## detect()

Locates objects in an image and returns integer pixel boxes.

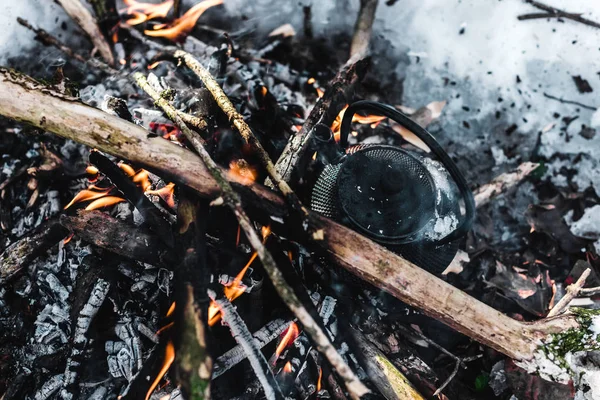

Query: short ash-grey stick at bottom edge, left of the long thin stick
[208,290,284,399]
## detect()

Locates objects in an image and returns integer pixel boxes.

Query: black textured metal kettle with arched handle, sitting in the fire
[311,100,475,274]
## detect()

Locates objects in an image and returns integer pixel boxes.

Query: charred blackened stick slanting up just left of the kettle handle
[267,58,368,186]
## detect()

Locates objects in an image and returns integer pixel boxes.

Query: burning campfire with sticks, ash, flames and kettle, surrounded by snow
[0,0,600,400]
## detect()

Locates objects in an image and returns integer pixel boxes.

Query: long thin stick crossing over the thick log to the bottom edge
[135,73,369,399]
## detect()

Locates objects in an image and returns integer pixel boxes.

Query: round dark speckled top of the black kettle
[338,145,435,241]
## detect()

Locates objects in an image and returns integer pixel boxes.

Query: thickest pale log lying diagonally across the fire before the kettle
[0,69,579,360]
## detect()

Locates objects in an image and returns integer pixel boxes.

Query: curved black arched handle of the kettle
[340,100,475,244]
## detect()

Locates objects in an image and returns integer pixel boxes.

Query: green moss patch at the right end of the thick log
[542,308,600,371]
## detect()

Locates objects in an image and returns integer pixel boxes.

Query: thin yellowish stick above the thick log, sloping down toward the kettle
[175,50,308,216]
